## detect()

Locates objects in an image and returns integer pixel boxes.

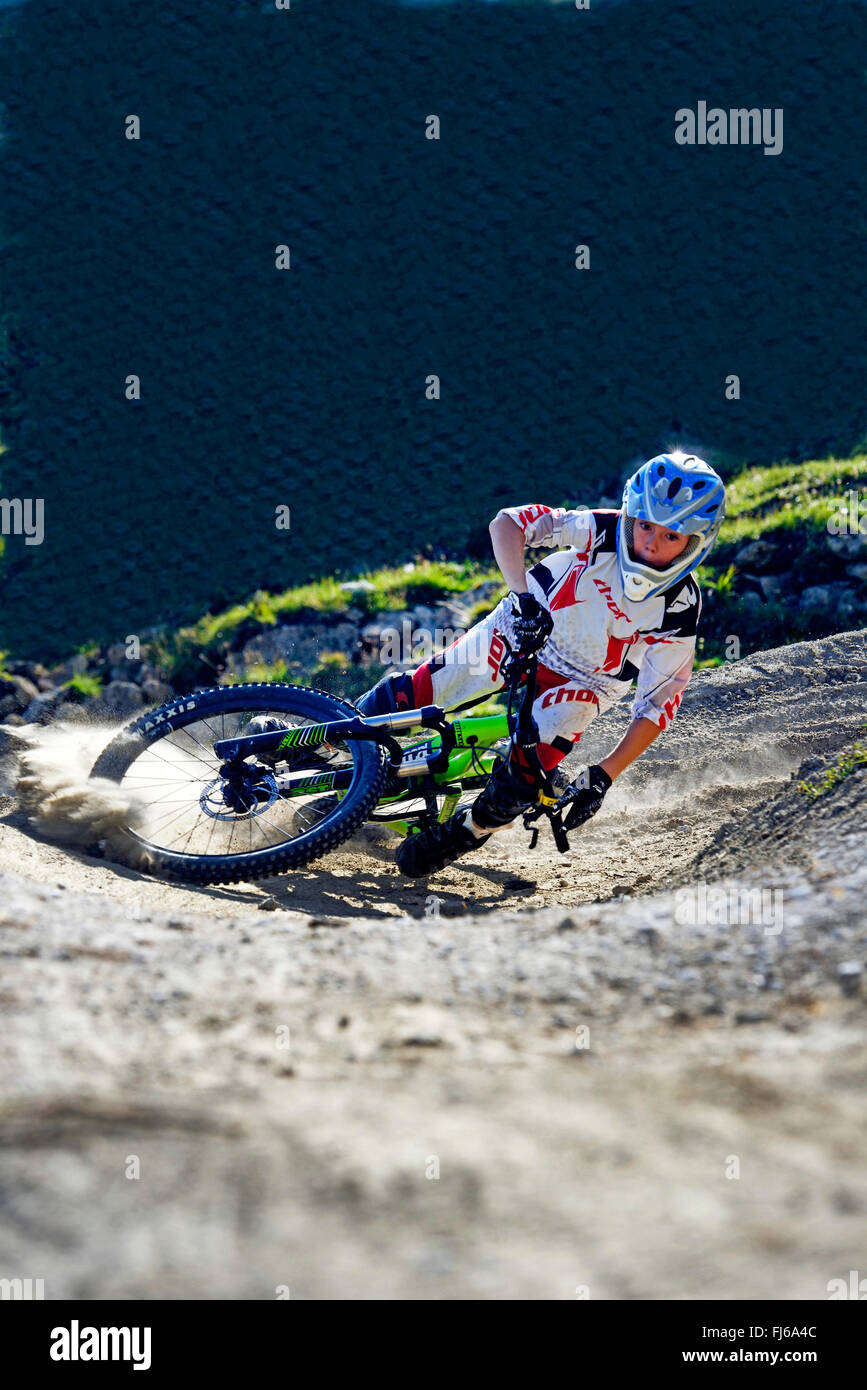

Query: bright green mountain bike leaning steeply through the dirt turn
[90,649,571,884]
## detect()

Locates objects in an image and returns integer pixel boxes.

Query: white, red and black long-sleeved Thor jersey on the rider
[499,503,702,728]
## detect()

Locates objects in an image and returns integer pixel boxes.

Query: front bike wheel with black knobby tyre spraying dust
[90,682,388,883]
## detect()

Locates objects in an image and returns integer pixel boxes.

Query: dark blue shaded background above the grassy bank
[0,0,867,657]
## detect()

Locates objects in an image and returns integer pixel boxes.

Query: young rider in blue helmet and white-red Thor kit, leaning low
[358,453,725,877]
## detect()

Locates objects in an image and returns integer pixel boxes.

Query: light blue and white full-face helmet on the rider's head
[617,453,725,599]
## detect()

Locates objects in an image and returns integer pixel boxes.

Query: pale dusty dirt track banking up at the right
[0,632,867,1300]
